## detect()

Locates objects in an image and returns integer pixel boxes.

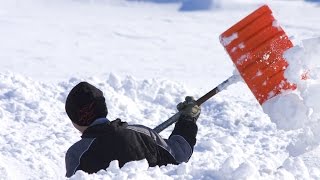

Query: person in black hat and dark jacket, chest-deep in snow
[66,82,200,177]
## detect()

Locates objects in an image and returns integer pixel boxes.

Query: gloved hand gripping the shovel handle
[177,96,201,122]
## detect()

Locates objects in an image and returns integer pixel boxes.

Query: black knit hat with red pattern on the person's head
[65,82,108,126]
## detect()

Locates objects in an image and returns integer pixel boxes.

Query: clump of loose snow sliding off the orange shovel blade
[263,38,320,156]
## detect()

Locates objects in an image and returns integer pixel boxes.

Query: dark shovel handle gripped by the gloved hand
[153,75,240,133]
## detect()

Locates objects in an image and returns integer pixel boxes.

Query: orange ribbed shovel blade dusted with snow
[220,5,296,104]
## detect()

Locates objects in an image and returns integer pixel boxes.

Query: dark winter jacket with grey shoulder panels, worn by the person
[65,116,198,177]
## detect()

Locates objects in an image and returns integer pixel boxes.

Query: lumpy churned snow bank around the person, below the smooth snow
[0,73,319,180]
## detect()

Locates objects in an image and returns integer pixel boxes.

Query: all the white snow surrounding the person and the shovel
[0,0,320,180]
